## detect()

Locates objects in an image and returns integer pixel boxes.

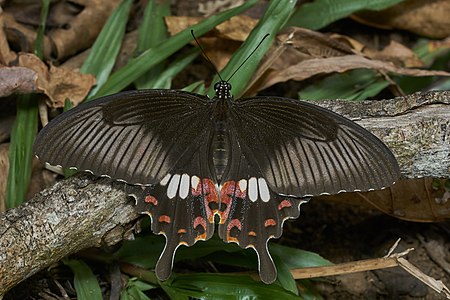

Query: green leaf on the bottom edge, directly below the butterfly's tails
[162,274,298,299]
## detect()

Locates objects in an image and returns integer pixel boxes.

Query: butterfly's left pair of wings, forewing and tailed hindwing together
[34,90,218,279]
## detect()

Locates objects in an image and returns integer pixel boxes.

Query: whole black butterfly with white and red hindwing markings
[34,81,400,283]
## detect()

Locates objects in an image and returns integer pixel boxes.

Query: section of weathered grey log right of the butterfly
[317,91,450,178]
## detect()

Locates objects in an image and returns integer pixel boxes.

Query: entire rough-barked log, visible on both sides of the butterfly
[0,92,450,295]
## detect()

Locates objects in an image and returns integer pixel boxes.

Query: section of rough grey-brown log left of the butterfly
[0,174,139,295]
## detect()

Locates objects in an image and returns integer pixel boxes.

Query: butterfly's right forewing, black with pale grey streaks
[230,97,400,197]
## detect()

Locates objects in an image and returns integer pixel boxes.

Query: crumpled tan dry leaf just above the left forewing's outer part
[19,53,95,107]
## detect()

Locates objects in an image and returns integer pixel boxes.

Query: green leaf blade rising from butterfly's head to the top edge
[208,0,296,98]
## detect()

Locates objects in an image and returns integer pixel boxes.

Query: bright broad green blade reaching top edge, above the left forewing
[80,0,133,100]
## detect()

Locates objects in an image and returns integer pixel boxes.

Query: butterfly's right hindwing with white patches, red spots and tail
[218,136,307,283]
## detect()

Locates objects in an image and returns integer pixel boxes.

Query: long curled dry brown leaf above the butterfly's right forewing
[245,27,436,95]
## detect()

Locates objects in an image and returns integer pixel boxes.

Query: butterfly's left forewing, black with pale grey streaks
[34,90,211,185]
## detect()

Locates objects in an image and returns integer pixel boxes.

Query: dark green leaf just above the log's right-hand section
[299,69,389,100]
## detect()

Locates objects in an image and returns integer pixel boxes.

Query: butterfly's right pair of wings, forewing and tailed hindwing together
[219,97,399,283]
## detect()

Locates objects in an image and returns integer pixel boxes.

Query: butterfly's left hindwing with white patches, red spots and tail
[138,135,219,280]
